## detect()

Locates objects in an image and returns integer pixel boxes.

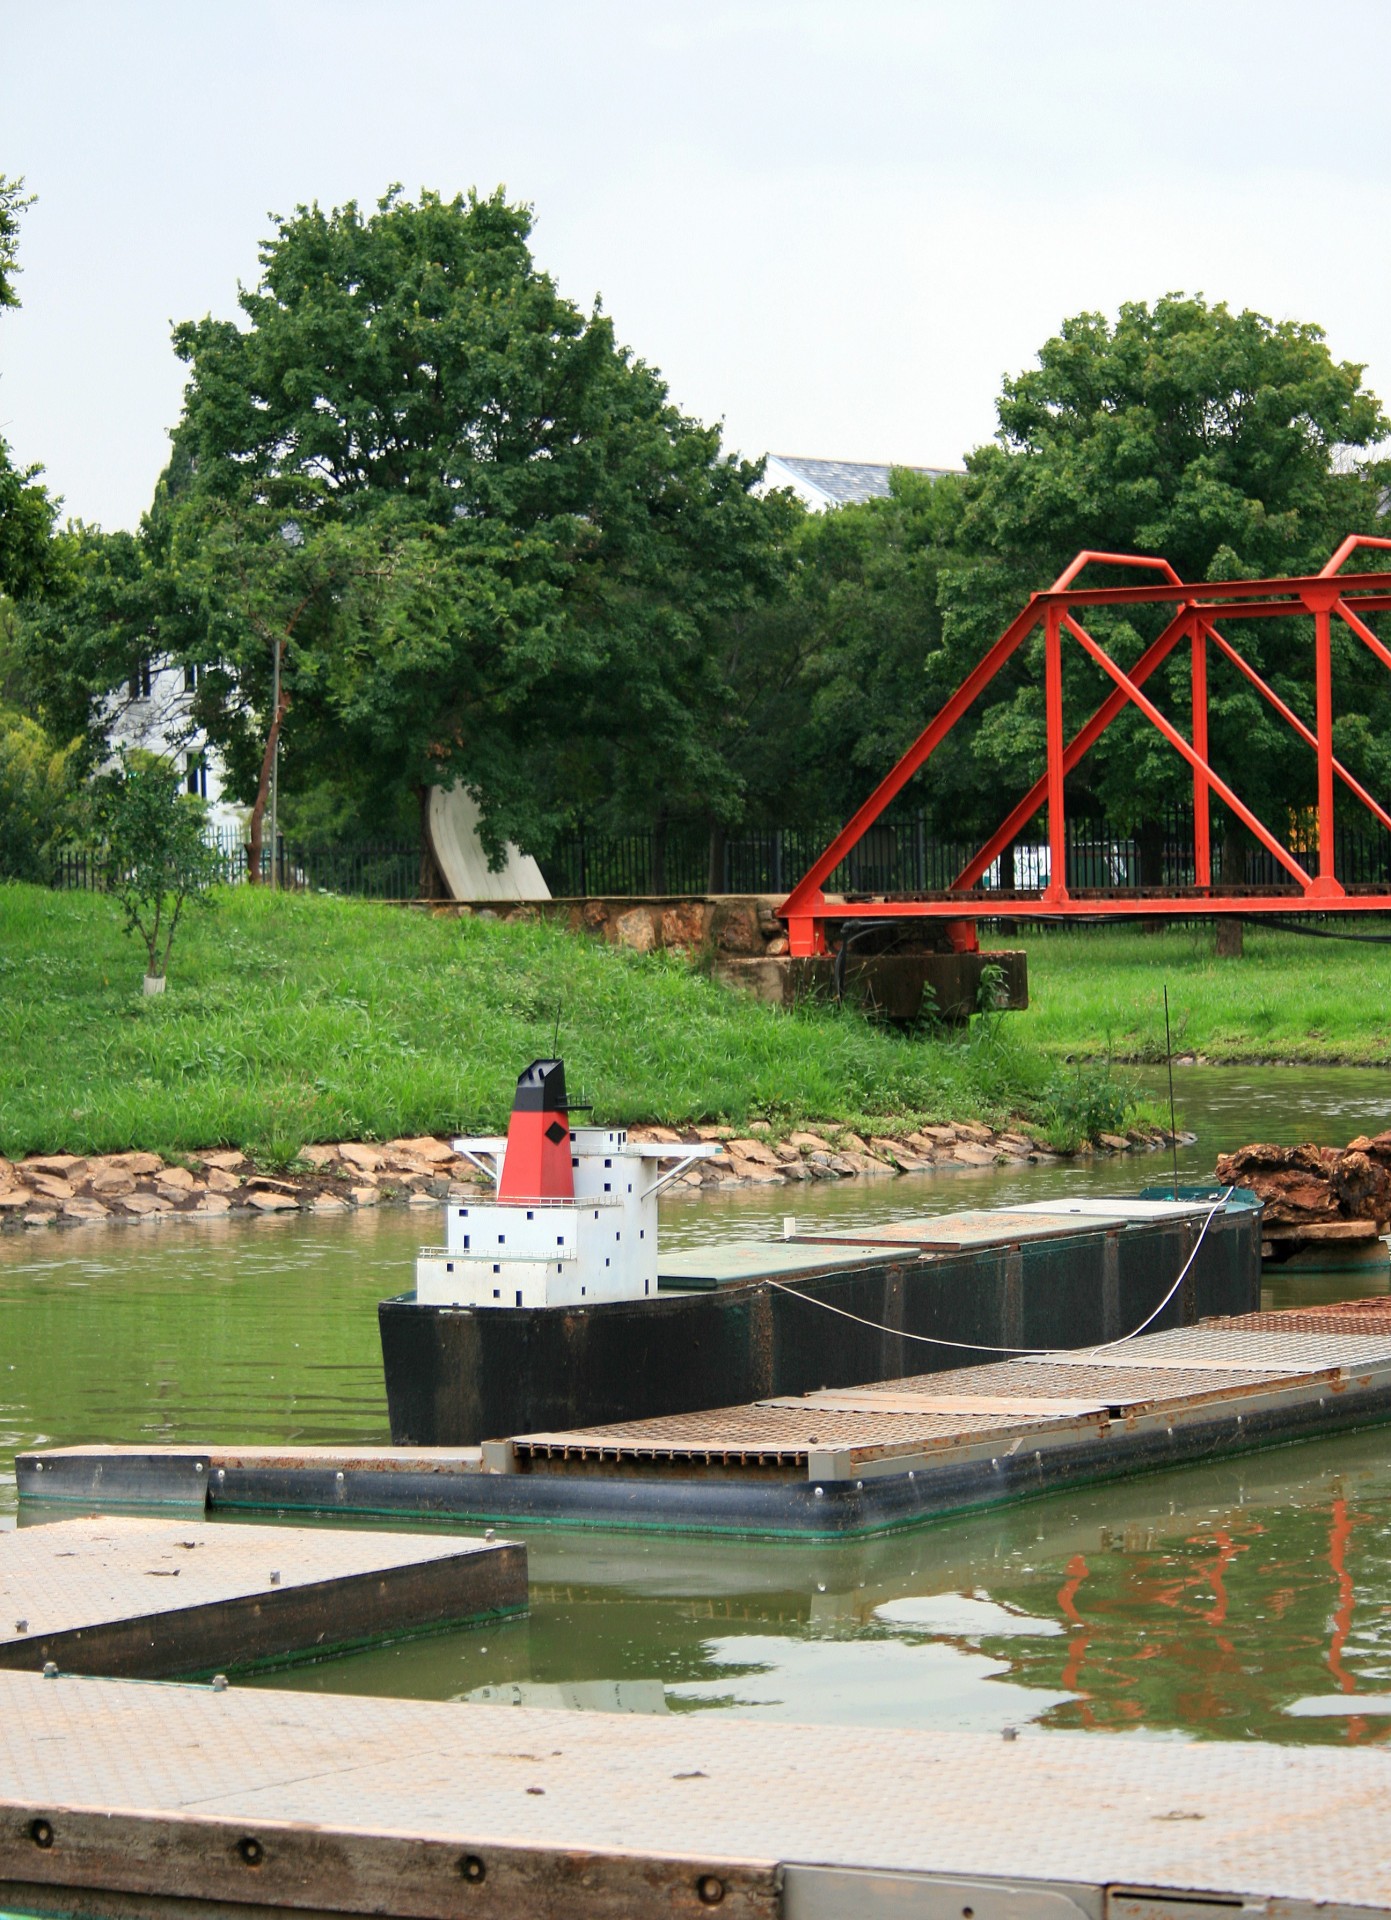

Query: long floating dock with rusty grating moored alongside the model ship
[15,1296,1391,1538]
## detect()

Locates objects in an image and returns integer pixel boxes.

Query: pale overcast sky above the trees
[0,0,1391,526]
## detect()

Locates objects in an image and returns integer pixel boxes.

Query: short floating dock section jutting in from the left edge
[0,1517,526,1678]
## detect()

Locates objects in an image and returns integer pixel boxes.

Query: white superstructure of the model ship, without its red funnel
[415,1127,719,1308]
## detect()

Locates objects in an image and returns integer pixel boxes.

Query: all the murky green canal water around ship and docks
[0,1068,1391,1743]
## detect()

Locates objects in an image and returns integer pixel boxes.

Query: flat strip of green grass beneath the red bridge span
[1022,920,1391,1066]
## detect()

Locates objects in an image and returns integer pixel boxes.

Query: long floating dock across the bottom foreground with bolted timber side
[0,1674,1391,1920]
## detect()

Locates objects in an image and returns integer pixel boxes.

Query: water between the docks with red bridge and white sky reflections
[263,1432,1391,1743]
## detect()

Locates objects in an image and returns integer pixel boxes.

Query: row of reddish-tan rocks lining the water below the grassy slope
[0,1119,1166,1231]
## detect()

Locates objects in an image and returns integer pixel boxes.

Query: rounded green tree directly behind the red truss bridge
[928,296,1391,877]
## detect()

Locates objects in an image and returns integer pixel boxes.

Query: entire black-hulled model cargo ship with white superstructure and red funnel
[378,1060,1260,1448]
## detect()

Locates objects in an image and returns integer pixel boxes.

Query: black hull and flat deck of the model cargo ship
[378,1187,1260,1448]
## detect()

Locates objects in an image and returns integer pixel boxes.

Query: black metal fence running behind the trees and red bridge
[52,810,1391,900]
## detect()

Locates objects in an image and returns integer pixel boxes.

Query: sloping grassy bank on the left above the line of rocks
[0,885,1124,1162]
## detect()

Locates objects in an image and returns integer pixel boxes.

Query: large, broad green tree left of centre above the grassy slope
[167,192,788,871]
